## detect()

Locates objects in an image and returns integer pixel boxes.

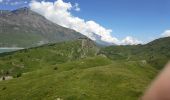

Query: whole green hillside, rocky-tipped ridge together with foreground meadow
[0,38,157,100]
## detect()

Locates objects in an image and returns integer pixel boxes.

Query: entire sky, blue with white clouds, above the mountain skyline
[0,0,170,45]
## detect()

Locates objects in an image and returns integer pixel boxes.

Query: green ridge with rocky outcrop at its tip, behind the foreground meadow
[0,39,98,76]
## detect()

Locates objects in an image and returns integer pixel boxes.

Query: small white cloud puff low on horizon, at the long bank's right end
[121,36,142,45]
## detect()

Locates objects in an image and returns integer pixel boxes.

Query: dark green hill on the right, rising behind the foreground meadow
[100,37,170,69]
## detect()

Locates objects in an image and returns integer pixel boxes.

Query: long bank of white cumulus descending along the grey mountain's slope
[29,0,141,44]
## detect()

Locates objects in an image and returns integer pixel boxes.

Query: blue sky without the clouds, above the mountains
[0,0,170,42]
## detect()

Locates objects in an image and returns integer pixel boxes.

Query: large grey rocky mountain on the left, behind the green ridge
[0,8,85,48]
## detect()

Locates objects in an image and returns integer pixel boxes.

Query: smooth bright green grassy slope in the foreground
[0,56,156,100]
